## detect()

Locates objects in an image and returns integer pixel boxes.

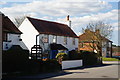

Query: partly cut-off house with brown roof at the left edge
[1,14,28,50]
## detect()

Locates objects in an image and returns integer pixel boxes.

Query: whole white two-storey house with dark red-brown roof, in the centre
[19,17,78,58]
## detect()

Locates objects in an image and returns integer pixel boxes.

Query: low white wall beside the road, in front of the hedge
[62,60,83,69]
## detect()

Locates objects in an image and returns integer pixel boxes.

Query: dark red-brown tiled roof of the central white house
[27,17,78,38]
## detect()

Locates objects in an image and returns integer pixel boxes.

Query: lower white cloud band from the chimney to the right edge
[58,9,118,26]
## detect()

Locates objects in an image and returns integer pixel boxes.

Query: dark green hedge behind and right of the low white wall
[69,50,102,66]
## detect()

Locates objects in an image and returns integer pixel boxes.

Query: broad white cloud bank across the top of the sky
[0,0,111,17]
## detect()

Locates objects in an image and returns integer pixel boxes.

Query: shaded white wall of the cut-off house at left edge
[3,33,28,50]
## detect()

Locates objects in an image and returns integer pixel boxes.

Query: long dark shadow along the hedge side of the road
[2,63,120,80]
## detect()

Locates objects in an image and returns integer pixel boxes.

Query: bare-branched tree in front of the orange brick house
[82,21,113,56]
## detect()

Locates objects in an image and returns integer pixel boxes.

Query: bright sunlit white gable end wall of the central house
[19,18,39,51]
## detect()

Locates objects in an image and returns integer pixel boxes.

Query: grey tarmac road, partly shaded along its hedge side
[2,61,120,80]
